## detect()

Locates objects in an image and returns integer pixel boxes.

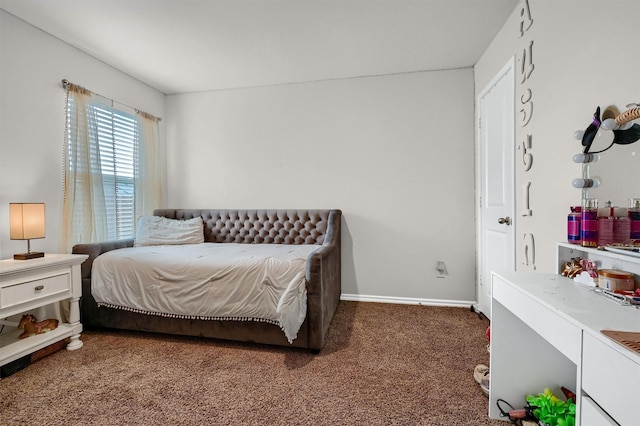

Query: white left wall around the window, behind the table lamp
[0,10,164,259]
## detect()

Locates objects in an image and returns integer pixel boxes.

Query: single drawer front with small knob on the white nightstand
[0,272,71,309]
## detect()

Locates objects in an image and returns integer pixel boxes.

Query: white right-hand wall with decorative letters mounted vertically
[474,0,640,272]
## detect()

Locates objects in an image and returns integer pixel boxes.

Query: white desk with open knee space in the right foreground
[489,272,640,426]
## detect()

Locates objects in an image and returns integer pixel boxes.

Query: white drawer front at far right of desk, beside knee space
[582,333,640,425]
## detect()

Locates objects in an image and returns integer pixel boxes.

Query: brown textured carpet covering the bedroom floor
[0,302,507,425]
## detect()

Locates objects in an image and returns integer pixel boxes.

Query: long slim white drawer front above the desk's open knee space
[492,275,582,365]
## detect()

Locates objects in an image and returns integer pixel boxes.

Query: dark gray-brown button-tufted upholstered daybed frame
[73,209,342,353]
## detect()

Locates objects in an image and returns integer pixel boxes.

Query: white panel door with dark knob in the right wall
[476,59,515,319]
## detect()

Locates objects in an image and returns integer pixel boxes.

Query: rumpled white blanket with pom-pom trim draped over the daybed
[91,243,320,343]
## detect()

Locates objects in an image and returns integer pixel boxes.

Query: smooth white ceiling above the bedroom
[0,0,518,94]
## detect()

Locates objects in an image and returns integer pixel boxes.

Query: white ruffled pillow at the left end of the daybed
[133,216,204,247]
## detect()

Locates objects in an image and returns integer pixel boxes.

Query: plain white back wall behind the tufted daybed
[166,69,475,301]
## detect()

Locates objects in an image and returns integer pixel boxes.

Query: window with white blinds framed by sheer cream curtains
[61,83,163,253]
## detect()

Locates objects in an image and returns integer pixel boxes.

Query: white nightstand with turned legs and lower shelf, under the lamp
[0,254,88,365]
